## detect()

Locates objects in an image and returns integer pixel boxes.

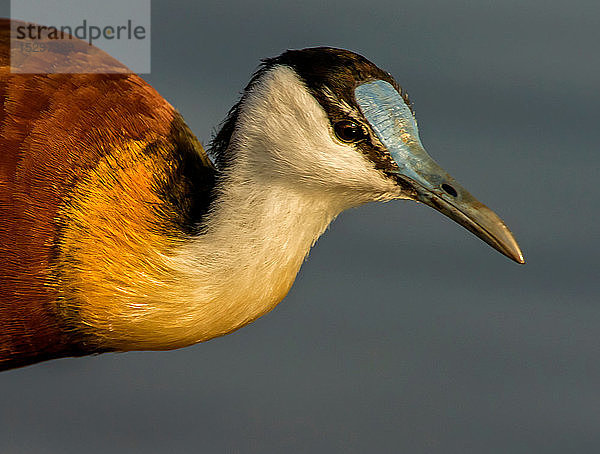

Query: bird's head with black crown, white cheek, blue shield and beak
[212,47,524,263]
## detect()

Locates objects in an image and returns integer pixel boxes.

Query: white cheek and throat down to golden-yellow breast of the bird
[103,63,399,349]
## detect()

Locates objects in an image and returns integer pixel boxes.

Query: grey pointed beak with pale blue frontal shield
[355,80,525,263]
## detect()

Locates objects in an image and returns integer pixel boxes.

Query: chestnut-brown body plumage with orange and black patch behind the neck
[0,20,215,369]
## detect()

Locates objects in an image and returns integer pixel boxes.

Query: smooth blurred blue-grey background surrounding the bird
[0,0,600,454]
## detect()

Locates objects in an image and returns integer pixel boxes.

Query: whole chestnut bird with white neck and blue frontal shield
[0,20,524,370]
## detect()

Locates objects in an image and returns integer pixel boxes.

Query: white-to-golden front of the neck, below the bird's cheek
[162,171,341,343]
